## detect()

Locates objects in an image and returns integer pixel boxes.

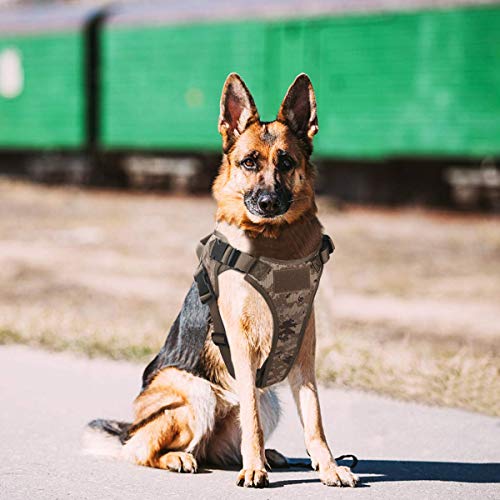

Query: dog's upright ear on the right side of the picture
[278,73,318,141]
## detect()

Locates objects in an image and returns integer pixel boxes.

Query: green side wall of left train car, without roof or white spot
[0,32,86,149]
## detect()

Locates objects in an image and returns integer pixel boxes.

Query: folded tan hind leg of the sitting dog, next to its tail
[121,368,216,472]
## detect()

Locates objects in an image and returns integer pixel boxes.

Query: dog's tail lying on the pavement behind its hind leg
[82,418,131,458]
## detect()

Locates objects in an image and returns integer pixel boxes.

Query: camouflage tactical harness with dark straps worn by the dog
[194,231,335,387]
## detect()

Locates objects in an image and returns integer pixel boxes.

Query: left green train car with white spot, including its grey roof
[0,6,100,150]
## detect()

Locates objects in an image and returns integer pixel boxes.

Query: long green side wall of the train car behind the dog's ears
[101,6,500,158]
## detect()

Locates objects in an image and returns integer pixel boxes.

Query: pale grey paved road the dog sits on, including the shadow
[0,346,500,500]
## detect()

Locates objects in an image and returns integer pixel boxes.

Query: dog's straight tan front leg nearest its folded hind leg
[219,272,269,488]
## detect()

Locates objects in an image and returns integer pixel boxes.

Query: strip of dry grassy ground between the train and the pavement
[0,180,500,415]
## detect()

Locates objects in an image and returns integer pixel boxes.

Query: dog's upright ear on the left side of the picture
[219,73,259,153]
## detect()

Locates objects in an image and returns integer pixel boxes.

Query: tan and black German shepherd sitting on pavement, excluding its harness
[84,73,358,488]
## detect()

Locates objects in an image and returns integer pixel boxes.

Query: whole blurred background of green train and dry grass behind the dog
[0,0,500,415]
